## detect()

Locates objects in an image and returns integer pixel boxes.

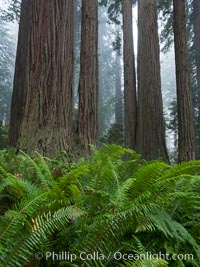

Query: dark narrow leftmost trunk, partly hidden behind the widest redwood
[8,0,32,147]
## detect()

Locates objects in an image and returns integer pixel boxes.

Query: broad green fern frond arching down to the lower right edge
[74,204,200,266]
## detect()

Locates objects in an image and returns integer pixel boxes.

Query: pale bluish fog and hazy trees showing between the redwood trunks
[0,0,197,161]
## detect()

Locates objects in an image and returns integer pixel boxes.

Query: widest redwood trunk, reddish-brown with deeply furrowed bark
[9,0,74,155]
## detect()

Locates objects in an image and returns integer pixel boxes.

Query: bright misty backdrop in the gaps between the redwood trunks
[0,0,176,153]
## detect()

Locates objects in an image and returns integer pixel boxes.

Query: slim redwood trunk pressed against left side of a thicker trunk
[122,0,137,149]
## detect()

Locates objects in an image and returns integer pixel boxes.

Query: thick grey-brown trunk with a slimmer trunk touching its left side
[136,0,168,161]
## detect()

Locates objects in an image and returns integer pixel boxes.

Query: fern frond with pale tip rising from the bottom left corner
[0,206,84,267]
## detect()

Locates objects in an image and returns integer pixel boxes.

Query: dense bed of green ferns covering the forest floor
[0,145,200,267]
